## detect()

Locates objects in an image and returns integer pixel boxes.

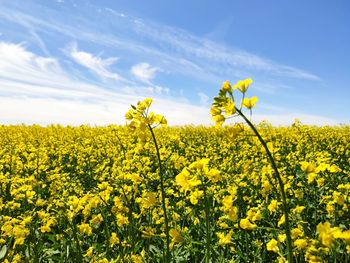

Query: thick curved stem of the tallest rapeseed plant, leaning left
[235,107,293,263]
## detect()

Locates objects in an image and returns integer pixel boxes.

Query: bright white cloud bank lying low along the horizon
[0,41,339,125]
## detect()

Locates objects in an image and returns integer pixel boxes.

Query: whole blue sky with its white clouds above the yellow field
[0,0,350,125]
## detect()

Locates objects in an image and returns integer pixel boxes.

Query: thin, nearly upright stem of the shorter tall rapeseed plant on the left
[148,124,170,262]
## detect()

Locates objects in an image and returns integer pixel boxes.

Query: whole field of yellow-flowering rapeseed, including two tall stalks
[0,79,350,262]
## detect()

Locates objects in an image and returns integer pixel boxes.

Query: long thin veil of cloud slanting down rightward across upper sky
[0,4,320,84]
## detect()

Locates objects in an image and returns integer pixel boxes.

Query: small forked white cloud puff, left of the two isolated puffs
[69,44,122,80]
